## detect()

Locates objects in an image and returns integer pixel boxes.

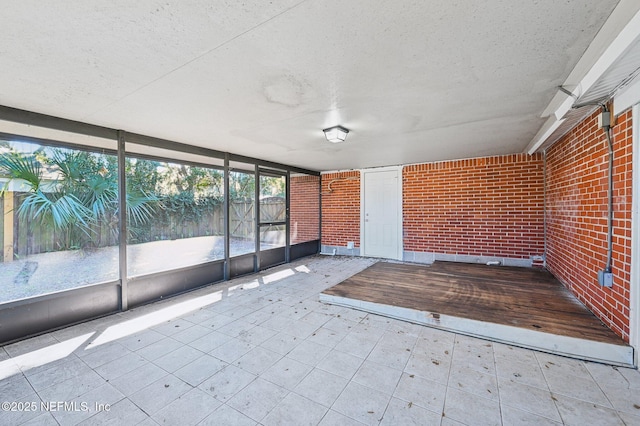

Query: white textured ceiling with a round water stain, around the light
[0,0,632,170]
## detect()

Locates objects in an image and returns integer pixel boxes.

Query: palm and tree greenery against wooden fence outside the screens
[0,143,285,249]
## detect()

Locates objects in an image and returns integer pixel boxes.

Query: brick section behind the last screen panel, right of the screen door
[289,175,320,244]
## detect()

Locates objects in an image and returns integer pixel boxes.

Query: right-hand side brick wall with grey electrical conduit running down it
[547,110,632,342]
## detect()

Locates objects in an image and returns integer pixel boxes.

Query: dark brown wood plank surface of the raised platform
[323,262,625,345]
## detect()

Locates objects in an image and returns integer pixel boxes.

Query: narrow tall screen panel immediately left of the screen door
[229,170,256,256]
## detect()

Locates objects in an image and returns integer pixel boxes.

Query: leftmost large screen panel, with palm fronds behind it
[0,142,118,303]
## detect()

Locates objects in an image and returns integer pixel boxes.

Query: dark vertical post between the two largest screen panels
[118,130,129,311]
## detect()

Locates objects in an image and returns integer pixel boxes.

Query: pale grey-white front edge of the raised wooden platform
[320,293,634,367]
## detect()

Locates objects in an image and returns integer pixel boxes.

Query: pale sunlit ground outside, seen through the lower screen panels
[0,236,272,303]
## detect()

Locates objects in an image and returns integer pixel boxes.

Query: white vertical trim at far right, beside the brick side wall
[629,104,640,366]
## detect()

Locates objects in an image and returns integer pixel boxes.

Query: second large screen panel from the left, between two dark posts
[126,157,224,276]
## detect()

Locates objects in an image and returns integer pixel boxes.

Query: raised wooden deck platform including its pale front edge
[320,261,633,366]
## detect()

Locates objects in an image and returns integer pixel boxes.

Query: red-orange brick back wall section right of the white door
[403,154,544,259]
